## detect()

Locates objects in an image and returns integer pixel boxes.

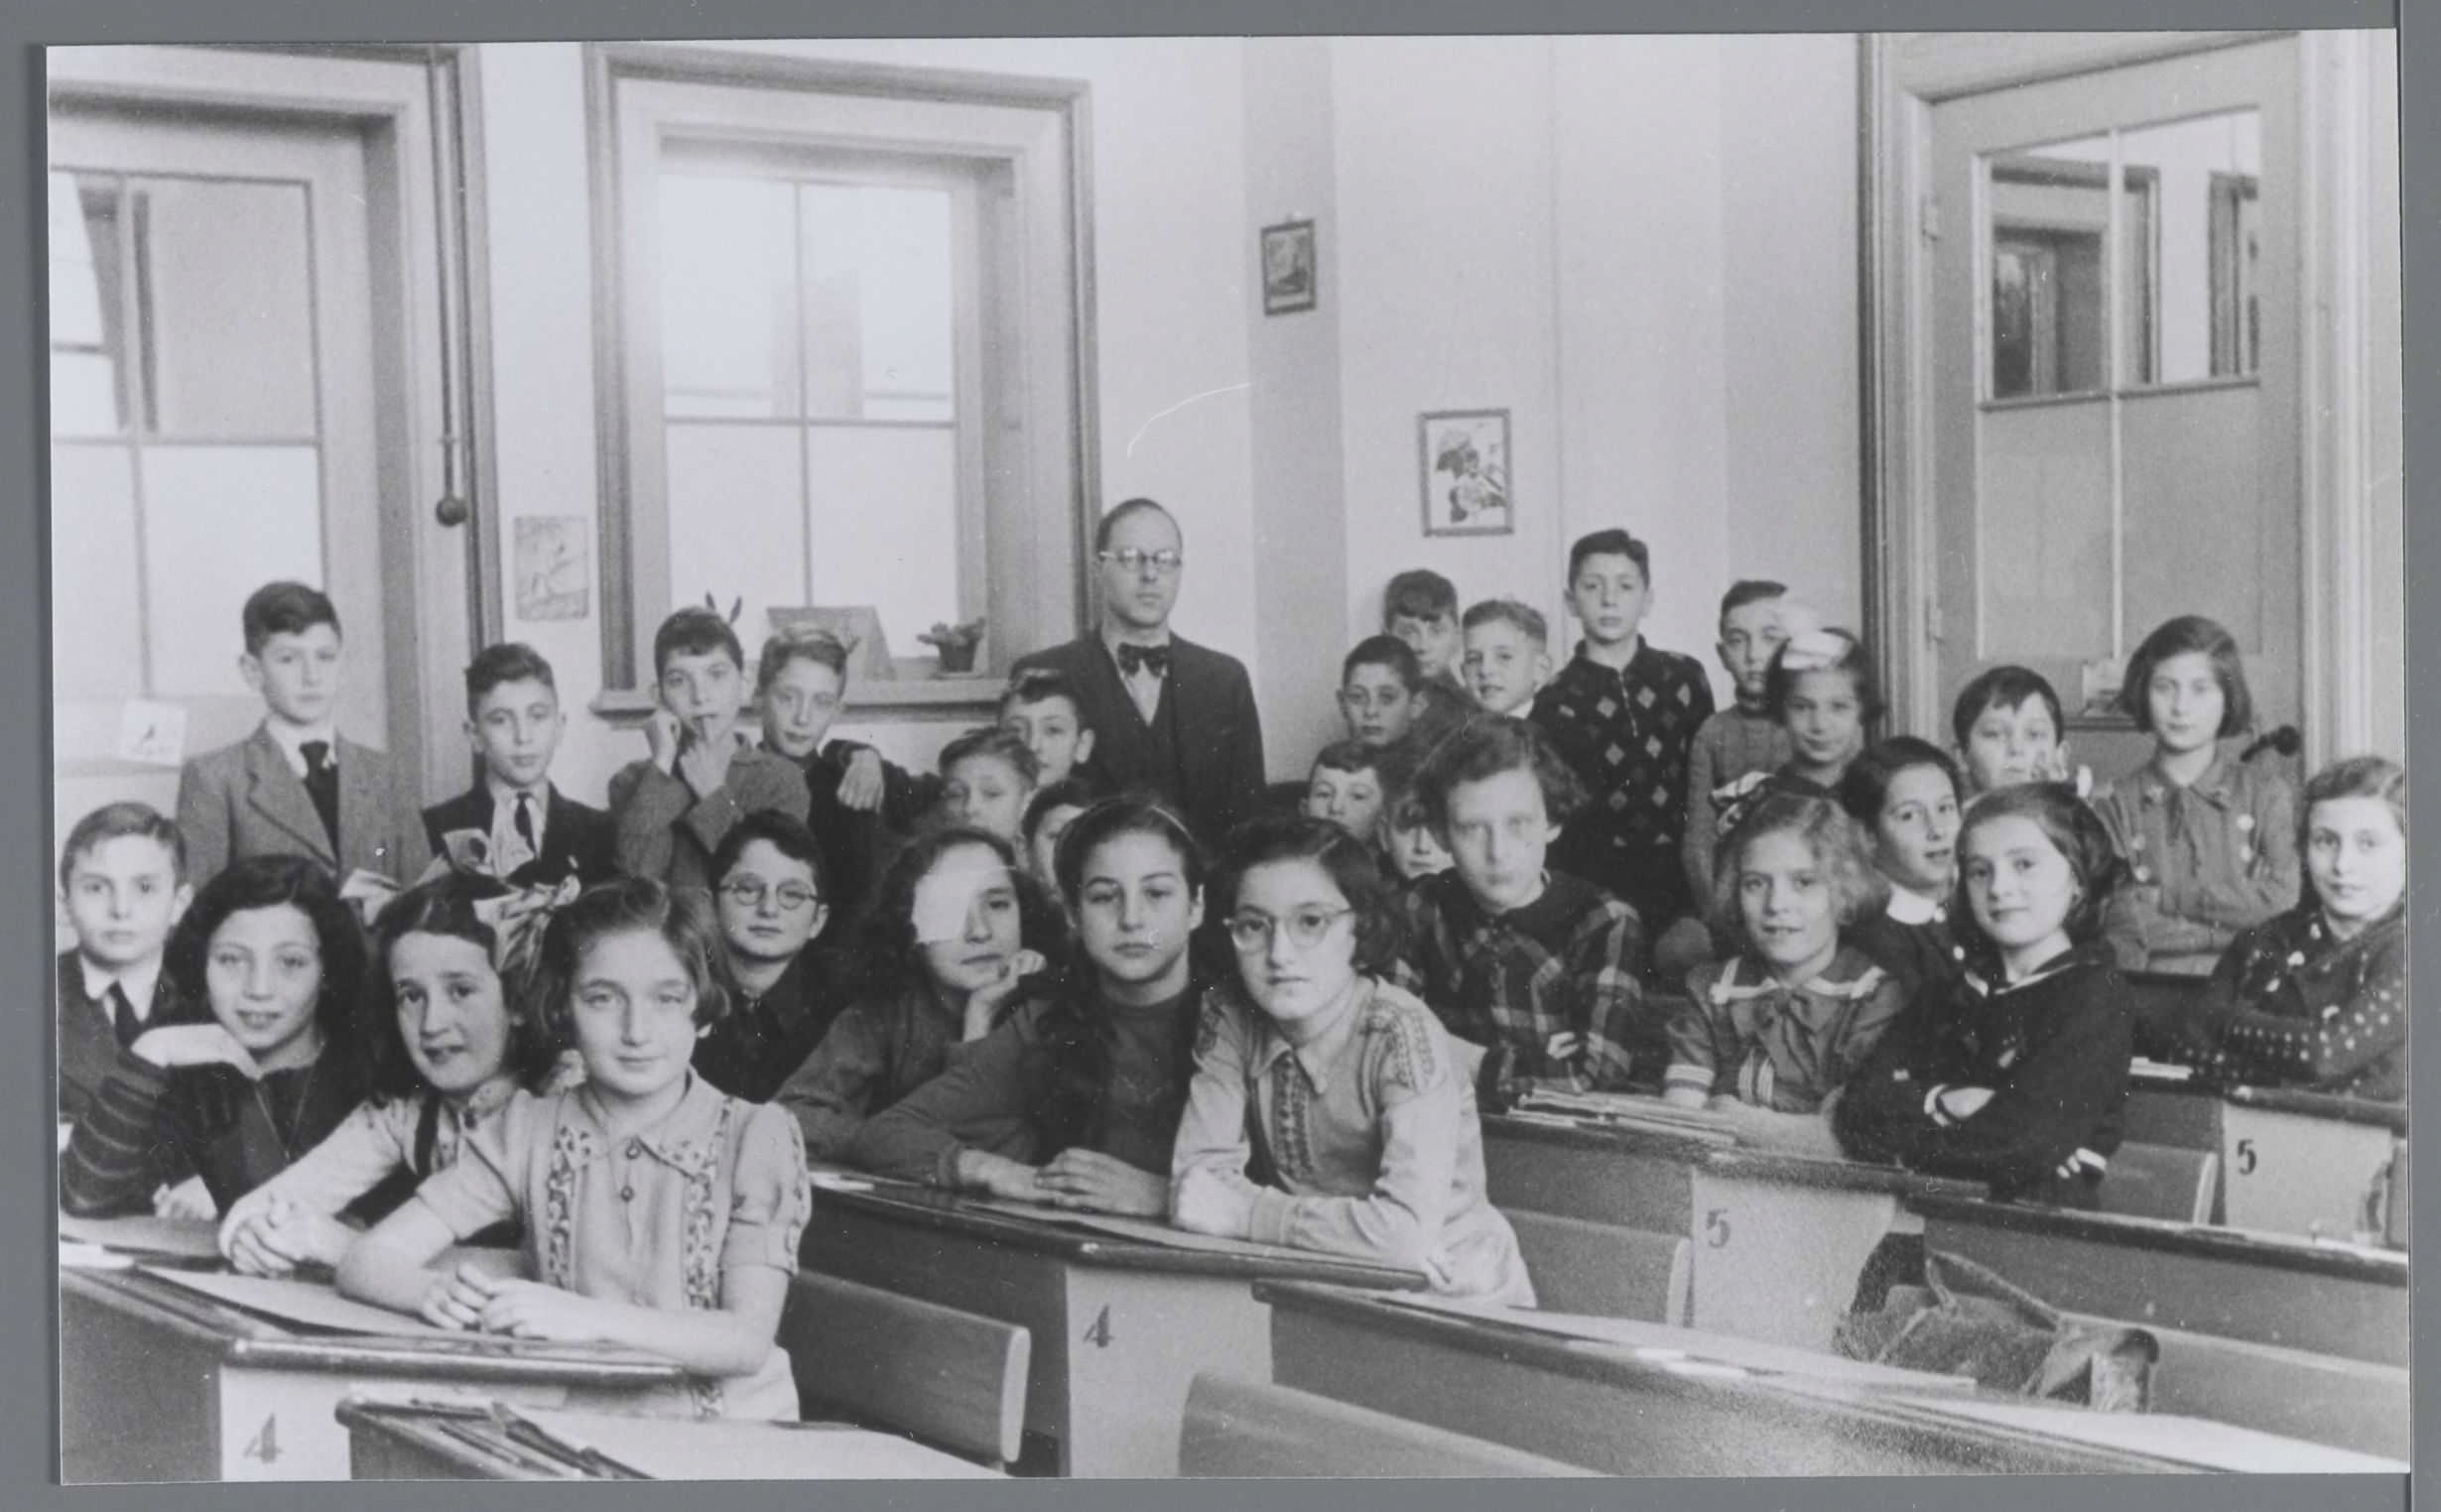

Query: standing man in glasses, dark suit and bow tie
[1010,497,1264,846]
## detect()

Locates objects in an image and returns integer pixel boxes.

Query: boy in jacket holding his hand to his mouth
[610,607,808,893]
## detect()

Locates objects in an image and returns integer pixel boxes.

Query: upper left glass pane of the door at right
[1987,137,2109,400]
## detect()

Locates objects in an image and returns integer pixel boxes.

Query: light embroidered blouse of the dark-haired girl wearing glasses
[1172,978,1533,1308]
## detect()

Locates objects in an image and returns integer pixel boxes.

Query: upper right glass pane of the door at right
[2119,110,2262,383]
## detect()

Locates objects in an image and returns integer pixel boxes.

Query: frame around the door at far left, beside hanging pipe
[47,44,500,803]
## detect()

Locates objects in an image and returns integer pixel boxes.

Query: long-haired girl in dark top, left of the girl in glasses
[847,798,1204,1217]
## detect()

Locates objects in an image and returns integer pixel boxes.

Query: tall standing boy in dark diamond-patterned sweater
[1533,529,1711,937]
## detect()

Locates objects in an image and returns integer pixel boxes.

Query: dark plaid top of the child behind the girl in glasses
[1389,871,1665,1087]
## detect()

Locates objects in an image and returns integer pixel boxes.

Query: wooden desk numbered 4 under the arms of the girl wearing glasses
[801,1183,1423,1475]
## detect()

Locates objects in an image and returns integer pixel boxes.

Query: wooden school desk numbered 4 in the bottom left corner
[59,1271,681,1485]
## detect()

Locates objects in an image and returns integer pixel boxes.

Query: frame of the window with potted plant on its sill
[585,44,1098,719]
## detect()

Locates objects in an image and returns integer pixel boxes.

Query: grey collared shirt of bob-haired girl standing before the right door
[2095,741,2302,975]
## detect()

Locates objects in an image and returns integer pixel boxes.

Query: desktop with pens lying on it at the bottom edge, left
[339,1402,1001,1480]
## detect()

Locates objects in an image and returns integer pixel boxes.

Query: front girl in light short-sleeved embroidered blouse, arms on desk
[339,878,813,1420]
